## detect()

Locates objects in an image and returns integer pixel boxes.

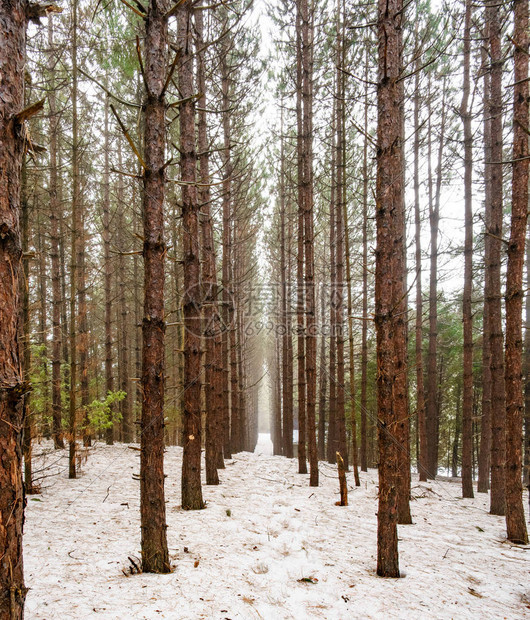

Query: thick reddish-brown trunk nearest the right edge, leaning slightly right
[505,0,530,545]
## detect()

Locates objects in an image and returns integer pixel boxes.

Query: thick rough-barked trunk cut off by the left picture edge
[0,0,27,620]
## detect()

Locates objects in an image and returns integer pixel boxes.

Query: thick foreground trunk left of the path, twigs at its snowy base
[140,0,171,573]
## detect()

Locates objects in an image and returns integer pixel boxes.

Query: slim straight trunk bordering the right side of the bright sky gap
[460,0,473,497]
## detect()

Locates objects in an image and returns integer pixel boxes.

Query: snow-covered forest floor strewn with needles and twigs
[24,436,530,620]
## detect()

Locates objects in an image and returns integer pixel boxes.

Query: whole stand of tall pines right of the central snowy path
[269,2,530,576]
